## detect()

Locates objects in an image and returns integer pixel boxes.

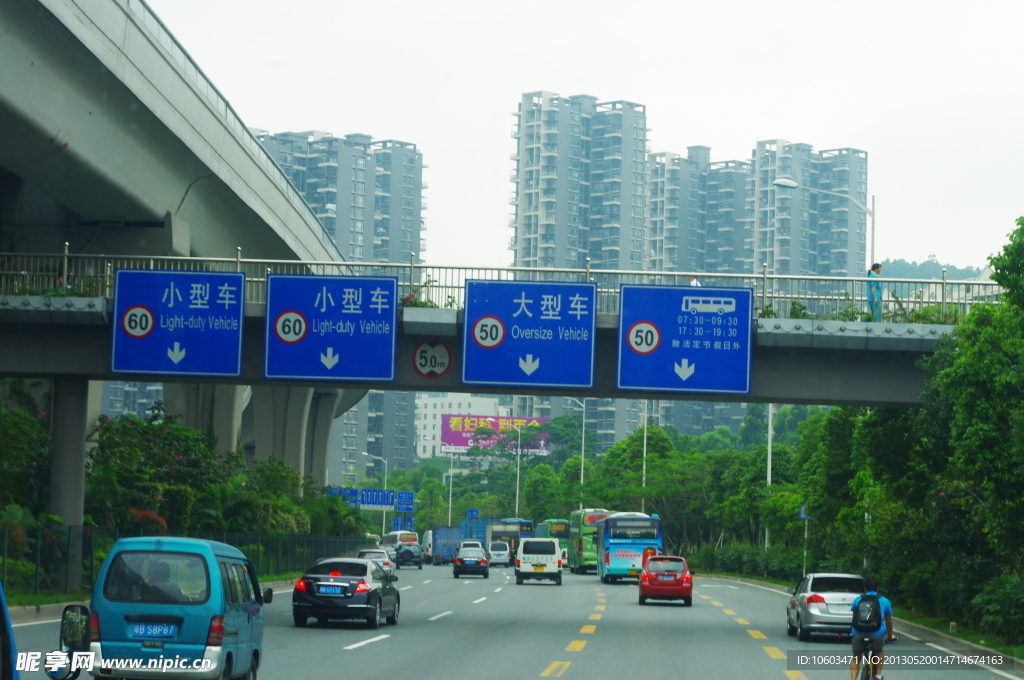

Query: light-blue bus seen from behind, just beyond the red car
[597,512,664,583]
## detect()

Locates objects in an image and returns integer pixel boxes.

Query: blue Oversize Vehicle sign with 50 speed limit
[462,281,597,387]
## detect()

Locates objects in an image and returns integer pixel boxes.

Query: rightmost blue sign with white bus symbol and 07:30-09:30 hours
[617,284,754,394]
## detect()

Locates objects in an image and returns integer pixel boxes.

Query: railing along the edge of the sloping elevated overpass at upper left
[113,0,343,260]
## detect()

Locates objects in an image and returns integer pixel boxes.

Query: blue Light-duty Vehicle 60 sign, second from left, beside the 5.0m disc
[264,274,398,382]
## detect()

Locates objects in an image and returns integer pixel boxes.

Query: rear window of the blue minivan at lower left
[103,551,210,604]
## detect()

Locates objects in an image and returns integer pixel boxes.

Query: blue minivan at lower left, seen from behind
[82,537,273,680]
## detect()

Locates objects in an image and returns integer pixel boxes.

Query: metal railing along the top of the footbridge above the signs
[0,248,1002,324]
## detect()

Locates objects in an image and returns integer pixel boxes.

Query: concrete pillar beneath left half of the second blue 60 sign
[253,387,313,476]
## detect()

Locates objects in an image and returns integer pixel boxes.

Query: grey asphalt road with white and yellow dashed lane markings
[14,566,1022,680]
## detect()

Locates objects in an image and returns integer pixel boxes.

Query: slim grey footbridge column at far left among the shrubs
[49,376,89,588]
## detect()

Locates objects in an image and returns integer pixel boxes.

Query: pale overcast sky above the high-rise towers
[148,0,1024,266]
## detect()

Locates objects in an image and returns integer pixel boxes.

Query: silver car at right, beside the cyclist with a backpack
[785,573,864,642]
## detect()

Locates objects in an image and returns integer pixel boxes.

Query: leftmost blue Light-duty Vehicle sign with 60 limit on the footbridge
[111,269,246,377]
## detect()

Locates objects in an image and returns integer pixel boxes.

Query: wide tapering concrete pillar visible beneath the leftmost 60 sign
[164,383,249,452]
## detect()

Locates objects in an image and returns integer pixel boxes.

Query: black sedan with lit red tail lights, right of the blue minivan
[292,557,401,628]
